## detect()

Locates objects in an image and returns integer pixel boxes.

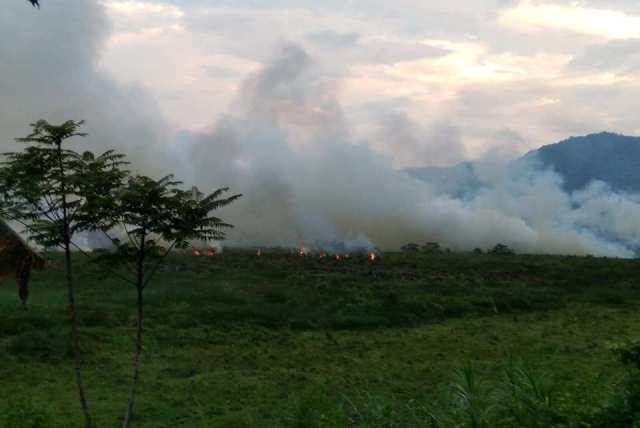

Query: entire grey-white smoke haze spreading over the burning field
[0,0,640,256]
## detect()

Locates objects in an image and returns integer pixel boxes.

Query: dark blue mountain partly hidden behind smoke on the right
[406,132,640,196]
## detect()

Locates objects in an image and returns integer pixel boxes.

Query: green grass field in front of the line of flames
[0,252,640,428]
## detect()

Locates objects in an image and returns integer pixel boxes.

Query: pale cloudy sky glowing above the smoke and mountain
[96,0,640,167]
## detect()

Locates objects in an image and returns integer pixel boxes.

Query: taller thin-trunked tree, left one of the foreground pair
[0,120,127,427]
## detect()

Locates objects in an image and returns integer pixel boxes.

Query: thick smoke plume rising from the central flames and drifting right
[180,45,640,257]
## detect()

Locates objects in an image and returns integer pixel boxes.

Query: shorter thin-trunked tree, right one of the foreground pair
[86,175,241,428]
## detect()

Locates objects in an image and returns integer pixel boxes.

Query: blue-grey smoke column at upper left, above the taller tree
[0,0,169,173]
